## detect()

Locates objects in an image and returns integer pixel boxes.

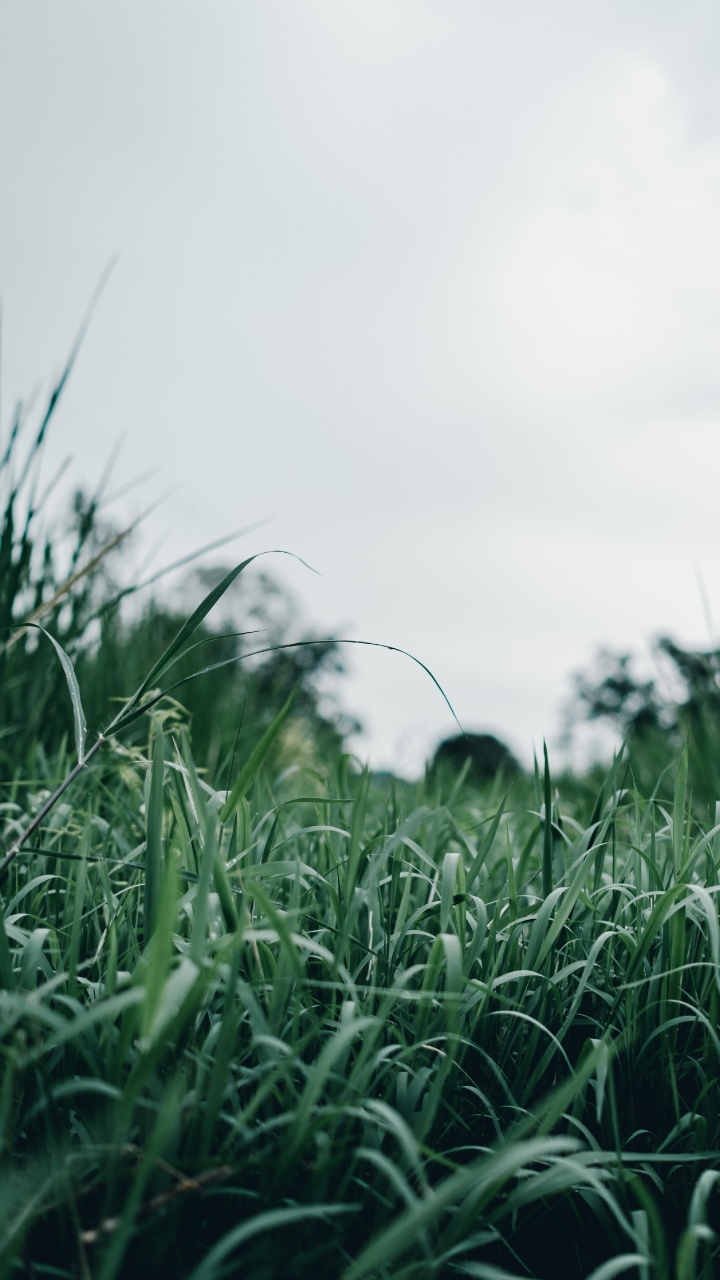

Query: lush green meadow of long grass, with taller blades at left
[0,345,720,1280]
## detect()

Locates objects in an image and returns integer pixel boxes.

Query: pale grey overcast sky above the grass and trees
[0,0,720,769]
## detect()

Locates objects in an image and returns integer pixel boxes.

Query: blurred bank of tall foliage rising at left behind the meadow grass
[0,349,357,777]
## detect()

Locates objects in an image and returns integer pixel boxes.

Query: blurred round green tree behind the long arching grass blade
[77,566,360,785]
